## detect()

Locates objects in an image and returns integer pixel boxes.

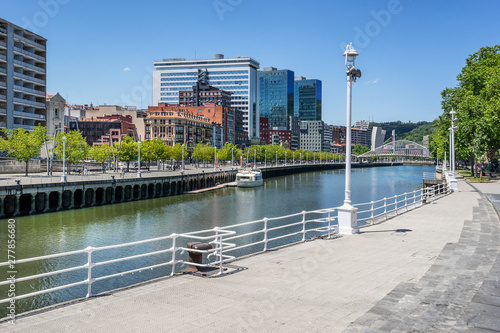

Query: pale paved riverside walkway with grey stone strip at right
[0,175,500,333]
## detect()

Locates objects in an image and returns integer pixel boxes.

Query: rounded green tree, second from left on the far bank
[54,130,89,173]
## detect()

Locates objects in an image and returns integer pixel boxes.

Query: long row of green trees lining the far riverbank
[0,126,343,175]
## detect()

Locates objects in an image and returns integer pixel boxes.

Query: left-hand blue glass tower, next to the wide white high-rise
[259,67,294,129]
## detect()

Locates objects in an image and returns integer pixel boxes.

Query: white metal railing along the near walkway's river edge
[0,183,451,303]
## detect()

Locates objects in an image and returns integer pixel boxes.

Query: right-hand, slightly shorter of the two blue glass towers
[294,76,322,121]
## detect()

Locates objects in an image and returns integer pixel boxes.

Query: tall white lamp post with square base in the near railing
[338,43,361,234]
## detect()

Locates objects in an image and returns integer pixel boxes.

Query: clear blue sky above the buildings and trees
[0,0,500,124]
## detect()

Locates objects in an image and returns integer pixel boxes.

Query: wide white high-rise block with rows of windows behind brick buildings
[153,54,259,139]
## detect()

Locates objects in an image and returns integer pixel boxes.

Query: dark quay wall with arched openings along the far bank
[0,163,402,218]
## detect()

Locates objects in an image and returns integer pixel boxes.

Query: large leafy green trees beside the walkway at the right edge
[430,45,500,176]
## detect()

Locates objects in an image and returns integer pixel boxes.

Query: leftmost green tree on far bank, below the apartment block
[0,126,47,176]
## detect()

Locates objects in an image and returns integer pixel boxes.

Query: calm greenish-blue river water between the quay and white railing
[0,166,434,318]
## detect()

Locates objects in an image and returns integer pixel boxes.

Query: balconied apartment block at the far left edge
[0,18,47,130]
